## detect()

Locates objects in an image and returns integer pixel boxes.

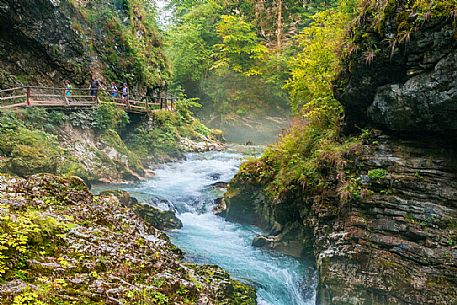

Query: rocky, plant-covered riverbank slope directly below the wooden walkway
[0,102,223,183]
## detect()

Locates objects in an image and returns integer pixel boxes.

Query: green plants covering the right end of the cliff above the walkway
[81,0,168,88]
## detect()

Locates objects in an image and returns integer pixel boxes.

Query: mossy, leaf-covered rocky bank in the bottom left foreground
[0,174,255,305]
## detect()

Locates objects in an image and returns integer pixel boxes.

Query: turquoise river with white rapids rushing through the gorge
[92,149,315,305]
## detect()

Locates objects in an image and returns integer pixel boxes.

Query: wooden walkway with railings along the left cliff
[0,86,176,113]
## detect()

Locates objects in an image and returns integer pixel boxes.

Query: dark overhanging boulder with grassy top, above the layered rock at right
[335,1,457,135]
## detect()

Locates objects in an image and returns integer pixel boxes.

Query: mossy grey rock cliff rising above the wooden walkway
[0,0,166,89]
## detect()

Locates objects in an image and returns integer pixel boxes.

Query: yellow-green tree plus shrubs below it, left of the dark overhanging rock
[235,1,364,201]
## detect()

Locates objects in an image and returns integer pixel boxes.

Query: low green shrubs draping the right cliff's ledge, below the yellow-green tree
[241,96,348,197]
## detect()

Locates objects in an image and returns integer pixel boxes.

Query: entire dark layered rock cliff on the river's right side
[225,1,457,305]
